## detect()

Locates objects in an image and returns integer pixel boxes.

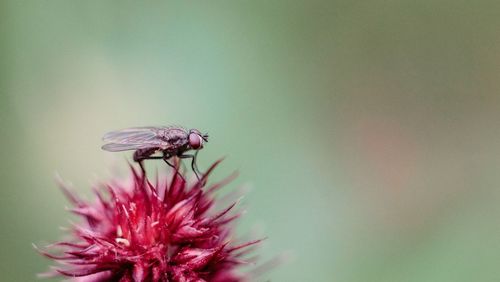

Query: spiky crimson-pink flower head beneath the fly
[41,161,259,282]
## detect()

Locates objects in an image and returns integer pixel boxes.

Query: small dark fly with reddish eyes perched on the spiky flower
[102,126,208,179]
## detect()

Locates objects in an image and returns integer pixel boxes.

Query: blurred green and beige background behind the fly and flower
[0,0,500,282]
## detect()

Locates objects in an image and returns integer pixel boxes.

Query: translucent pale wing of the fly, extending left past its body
[102,127,166,152]
